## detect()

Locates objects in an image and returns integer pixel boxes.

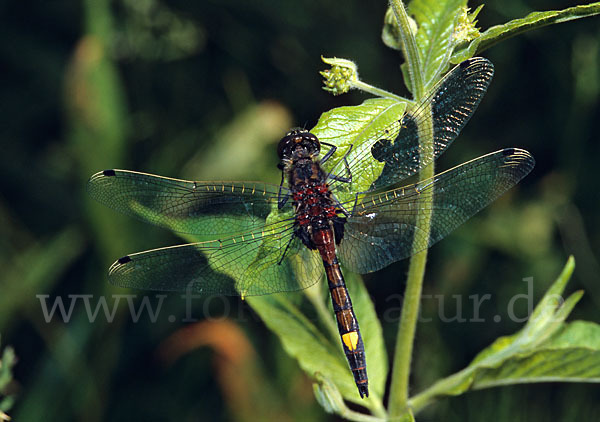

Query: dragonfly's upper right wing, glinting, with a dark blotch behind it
[331,57,494,190]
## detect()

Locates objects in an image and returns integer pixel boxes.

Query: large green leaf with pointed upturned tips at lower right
[410,257,600,412]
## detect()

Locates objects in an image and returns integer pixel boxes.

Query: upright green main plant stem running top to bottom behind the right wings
[388,0,434,419]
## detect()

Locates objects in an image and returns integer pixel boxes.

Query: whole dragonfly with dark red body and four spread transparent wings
[87,57,535,398]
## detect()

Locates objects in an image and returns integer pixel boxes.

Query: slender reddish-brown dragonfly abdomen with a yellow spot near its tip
[312,228,369,398]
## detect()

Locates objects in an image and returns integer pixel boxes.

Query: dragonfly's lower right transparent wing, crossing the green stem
[338,148,535,273]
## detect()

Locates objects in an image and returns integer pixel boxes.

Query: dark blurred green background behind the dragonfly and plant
[0,0,600,421]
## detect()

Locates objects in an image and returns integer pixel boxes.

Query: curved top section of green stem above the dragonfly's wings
[390,0,424,100]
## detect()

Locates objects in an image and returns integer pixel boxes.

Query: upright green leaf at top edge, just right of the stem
[403,0,467,91]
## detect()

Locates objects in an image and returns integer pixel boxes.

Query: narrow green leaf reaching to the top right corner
[451,2,600,63]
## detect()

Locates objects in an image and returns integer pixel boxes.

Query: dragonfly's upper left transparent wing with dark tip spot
[87,170,291,238]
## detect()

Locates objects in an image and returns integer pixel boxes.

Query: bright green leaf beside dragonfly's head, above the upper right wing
[311,98,409,202]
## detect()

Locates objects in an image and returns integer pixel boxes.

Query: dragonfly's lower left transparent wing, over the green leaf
[109,224,322,296]
